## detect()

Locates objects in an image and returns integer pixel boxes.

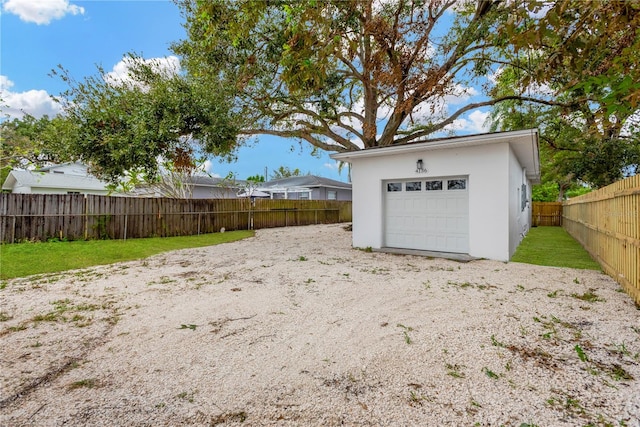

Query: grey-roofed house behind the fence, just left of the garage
[257,175,351,200]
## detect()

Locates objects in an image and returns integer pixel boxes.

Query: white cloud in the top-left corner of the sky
[2,0,84,25]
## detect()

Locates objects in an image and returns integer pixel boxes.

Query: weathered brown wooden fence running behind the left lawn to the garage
[0,194,351,243]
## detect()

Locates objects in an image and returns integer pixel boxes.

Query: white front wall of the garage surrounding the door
[351,142,510,261]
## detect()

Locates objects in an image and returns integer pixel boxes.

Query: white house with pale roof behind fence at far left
[2,163,109,195]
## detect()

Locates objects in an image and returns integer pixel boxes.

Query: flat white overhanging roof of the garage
[331,129,540,183]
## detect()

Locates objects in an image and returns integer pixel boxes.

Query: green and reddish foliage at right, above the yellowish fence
[492,0,640,191]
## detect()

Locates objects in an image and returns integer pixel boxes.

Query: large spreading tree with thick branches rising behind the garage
[173,0,536,151]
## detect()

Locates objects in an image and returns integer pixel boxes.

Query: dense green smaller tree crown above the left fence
[54,56,237,181]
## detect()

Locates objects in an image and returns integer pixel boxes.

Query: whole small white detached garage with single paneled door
[331,129,540,261]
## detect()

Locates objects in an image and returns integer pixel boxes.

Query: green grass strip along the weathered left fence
[0,231,254,280]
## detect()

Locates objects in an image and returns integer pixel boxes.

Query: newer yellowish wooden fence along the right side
[563,175,640,304]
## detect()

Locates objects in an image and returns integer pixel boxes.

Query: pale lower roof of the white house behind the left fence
[2,170,107,191]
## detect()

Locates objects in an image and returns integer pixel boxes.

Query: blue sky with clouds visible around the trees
[0,0,486,181]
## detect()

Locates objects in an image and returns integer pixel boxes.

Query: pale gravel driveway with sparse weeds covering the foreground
[0,225,640,427]
